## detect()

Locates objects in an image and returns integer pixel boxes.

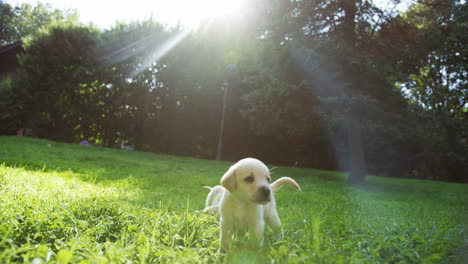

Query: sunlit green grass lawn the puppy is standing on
[0,137,468,264]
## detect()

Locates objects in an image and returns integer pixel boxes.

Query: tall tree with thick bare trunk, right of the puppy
[250,0,414,183]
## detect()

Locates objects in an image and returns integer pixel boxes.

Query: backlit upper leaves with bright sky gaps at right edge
[402,0,468,117]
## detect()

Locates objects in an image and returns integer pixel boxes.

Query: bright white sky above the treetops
[4,0,409,29]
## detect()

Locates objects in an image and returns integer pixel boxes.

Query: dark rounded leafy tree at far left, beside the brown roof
[13,26,105,141]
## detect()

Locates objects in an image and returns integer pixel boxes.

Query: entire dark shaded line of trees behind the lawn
[0,0,468,182]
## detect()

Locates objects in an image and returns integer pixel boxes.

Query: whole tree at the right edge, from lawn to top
[399,0,468,181]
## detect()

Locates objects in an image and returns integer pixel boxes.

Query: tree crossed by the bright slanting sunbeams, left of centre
[99,19,171,150]
